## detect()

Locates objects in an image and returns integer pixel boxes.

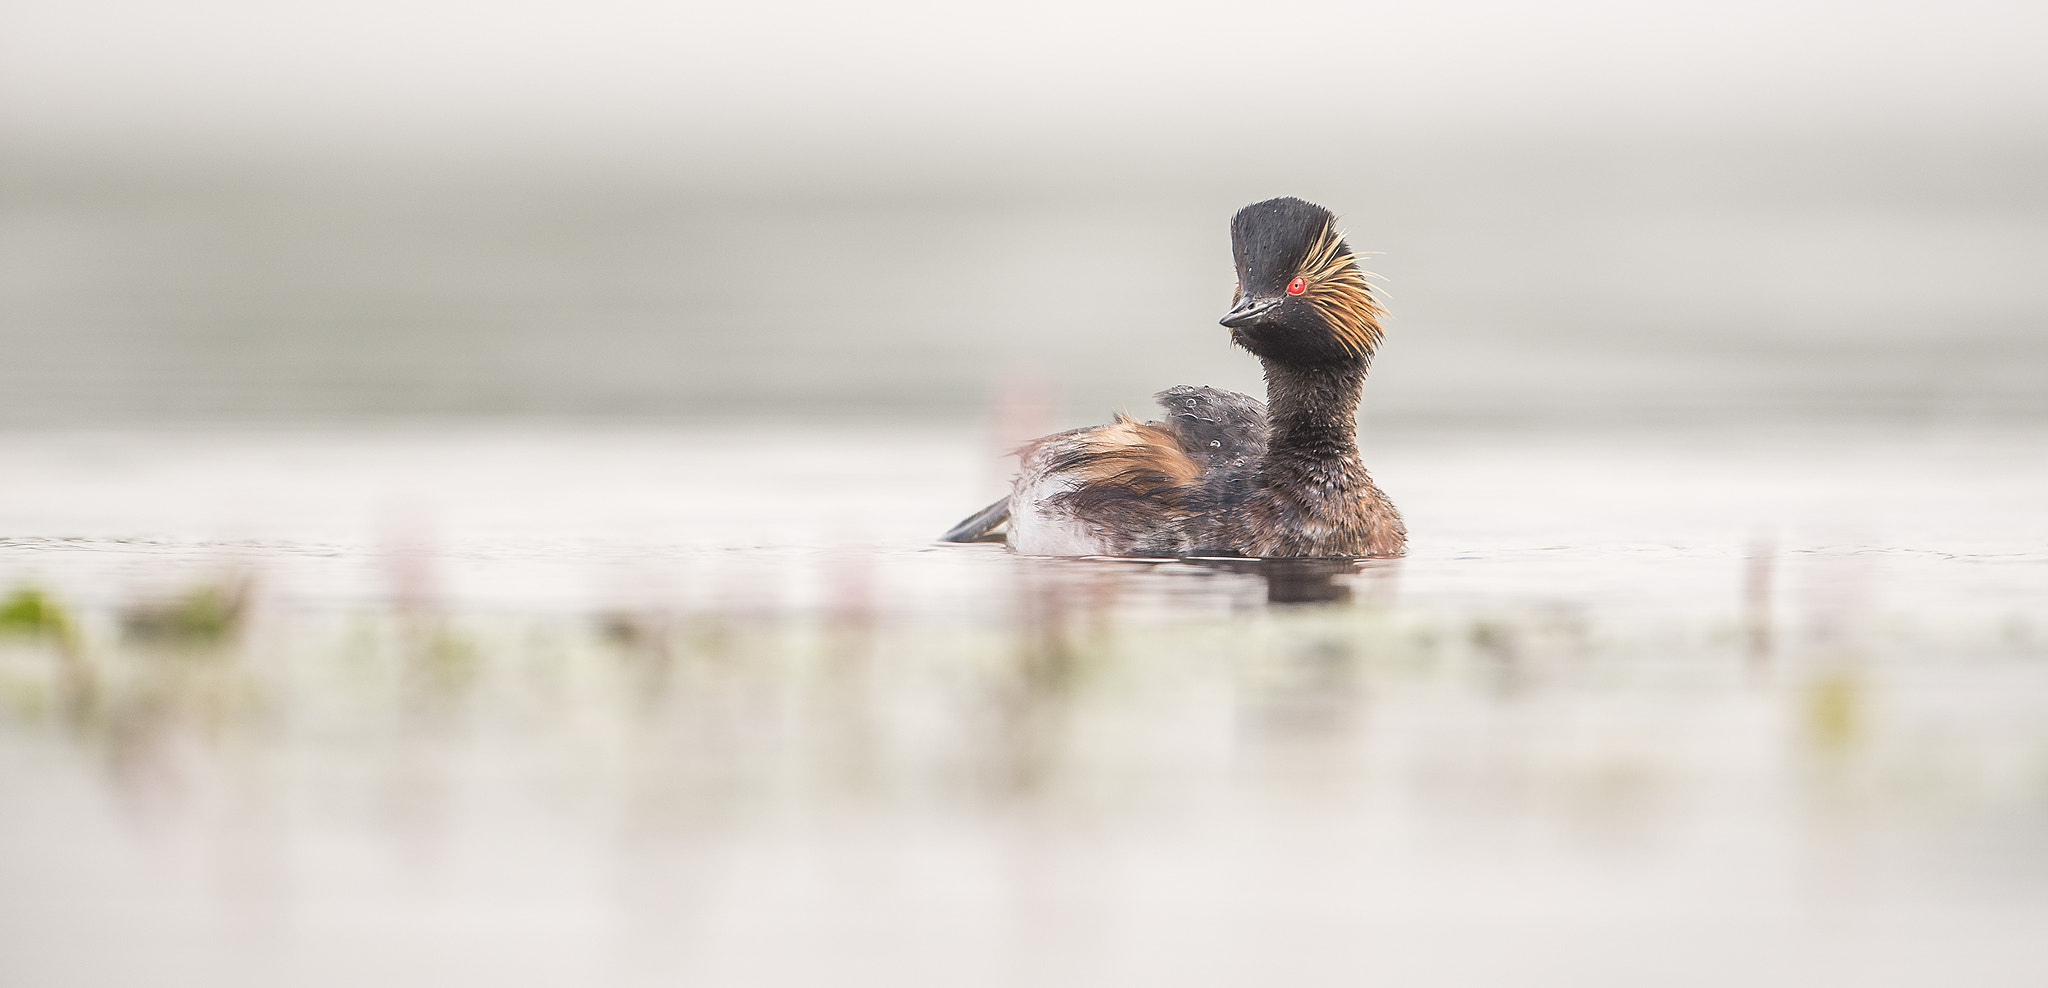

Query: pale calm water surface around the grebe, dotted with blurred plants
[0,428,2048,986]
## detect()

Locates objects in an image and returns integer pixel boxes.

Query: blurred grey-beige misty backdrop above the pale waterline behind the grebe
[0,0,2048,428]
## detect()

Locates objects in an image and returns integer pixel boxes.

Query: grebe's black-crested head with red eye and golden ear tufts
[1221,197,1382,367]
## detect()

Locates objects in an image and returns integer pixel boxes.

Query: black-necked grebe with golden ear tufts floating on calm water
[942,199,1407,555]
